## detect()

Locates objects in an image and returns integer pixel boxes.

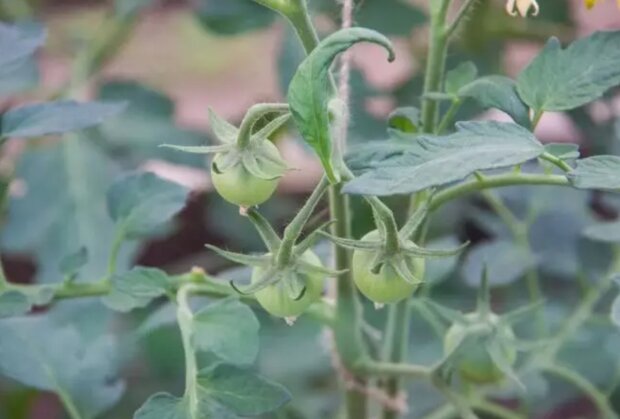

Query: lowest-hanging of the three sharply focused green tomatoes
[252,250,325,317]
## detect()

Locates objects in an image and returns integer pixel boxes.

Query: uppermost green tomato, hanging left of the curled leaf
[211,141,281,207]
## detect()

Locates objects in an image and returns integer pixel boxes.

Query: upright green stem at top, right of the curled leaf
[422,0,450,133]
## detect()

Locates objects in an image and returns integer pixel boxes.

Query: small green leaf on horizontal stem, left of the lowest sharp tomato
[103,266,172,312]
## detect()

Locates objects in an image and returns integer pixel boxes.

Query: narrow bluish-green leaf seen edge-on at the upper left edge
[0,100,125,138]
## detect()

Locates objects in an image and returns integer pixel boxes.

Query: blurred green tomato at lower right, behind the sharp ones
[444,313,517,384]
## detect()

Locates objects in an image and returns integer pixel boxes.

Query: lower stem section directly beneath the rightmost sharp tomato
[383,299,411,419]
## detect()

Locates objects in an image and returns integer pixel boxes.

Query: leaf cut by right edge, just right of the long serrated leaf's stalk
[568,156,620,190]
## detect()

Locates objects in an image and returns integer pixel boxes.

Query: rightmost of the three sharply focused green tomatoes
[351,230,425,304]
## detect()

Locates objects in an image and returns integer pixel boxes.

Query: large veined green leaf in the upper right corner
[517,31,620,111]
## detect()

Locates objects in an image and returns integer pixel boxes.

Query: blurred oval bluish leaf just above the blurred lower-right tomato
[461,240,537,287]
